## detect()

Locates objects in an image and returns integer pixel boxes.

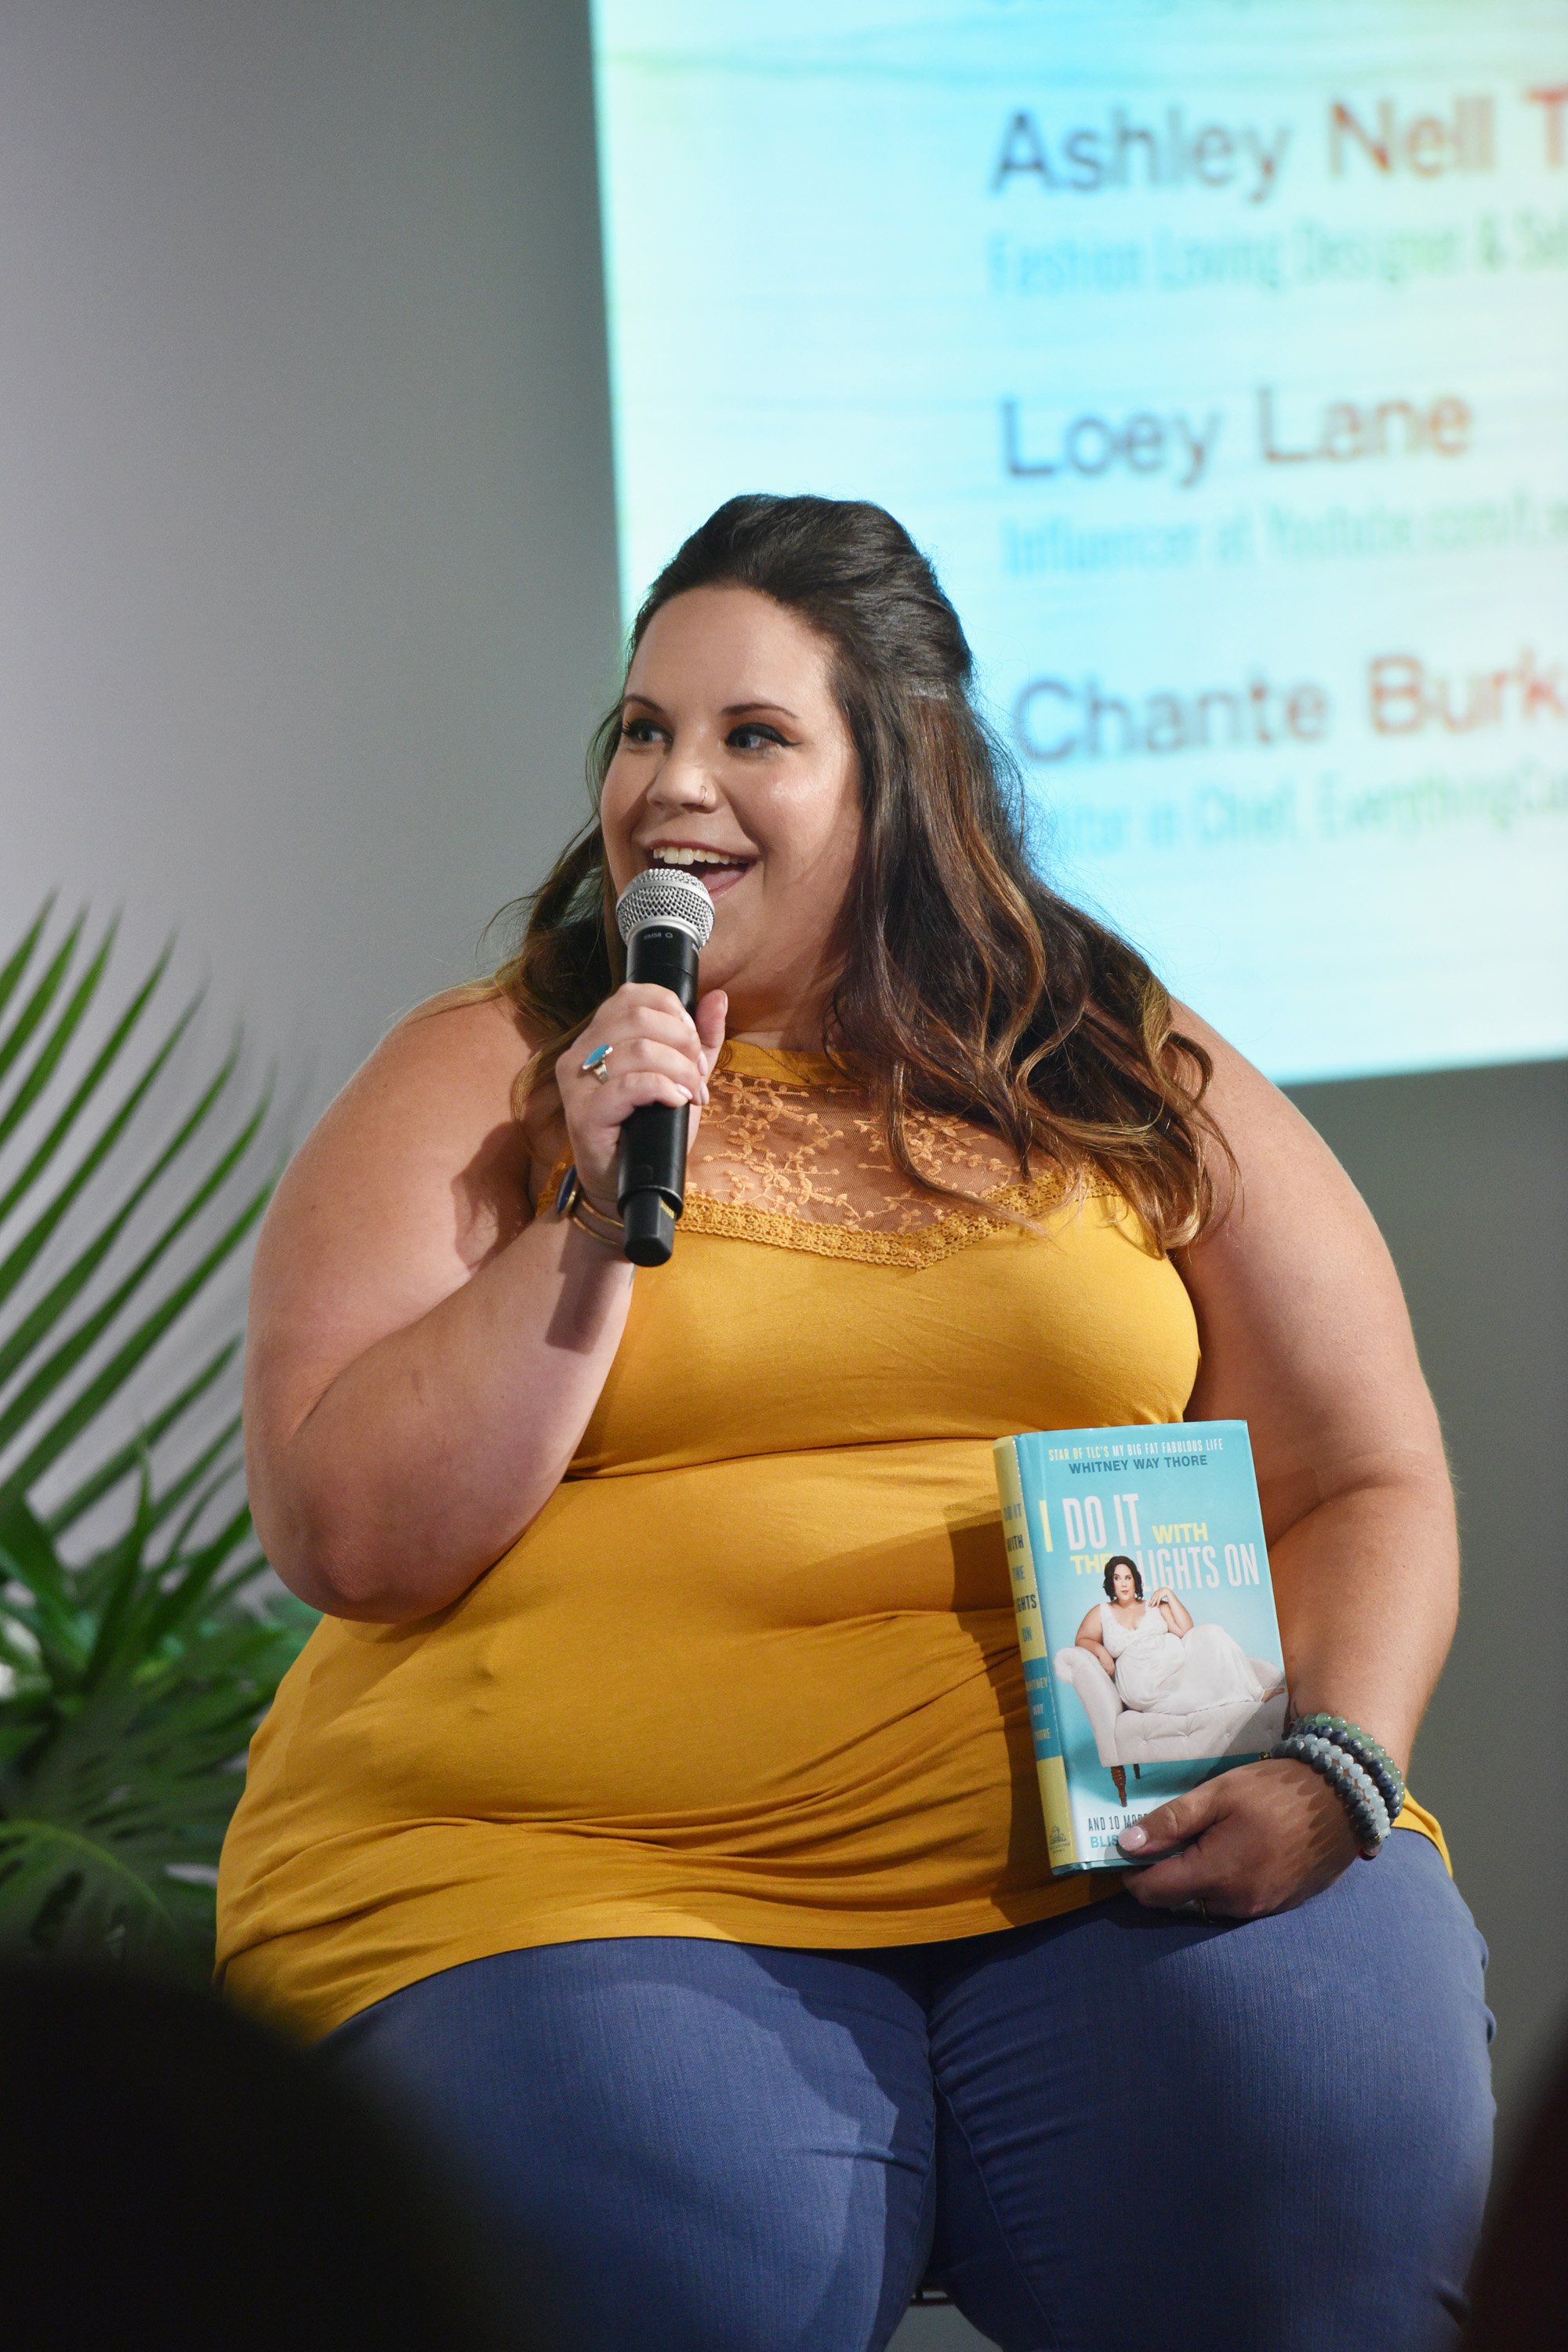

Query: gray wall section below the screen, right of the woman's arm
[1293,1061,1568,2143]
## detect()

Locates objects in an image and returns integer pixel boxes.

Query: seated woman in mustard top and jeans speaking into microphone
[221,496,1488,2352]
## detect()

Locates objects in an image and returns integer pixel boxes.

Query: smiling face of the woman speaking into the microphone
[600,588,860,1047]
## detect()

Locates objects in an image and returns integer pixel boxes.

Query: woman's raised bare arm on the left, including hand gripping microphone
[245,990,717,1623]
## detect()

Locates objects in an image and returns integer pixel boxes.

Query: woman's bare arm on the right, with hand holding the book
[1123,1011,1457,1917]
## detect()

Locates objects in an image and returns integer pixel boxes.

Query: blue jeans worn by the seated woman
[325,1830,1493,2352]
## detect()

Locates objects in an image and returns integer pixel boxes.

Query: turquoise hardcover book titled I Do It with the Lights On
[992,1421,1288,1875]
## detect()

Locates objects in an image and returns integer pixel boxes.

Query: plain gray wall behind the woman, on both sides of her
[0,13,1568,2345]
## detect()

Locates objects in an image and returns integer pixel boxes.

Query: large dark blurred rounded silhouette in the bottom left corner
[0,1969,546,2352]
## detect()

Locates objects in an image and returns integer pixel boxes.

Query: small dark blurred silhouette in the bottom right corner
[1465,2049,1568,2352]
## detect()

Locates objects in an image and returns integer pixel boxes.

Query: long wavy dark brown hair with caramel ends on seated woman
[496,494,1225,1249]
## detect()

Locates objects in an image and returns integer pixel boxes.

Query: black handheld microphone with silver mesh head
[616,866,713,1265]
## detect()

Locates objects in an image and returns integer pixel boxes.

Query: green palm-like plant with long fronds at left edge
[0,906,315,1976]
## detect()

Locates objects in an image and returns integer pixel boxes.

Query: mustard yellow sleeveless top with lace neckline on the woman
[219,1044,1448,2032]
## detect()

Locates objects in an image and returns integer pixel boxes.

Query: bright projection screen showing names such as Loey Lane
[595,0,1568,1080]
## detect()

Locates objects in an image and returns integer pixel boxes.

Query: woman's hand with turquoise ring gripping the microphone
[555,981,729,1216]
